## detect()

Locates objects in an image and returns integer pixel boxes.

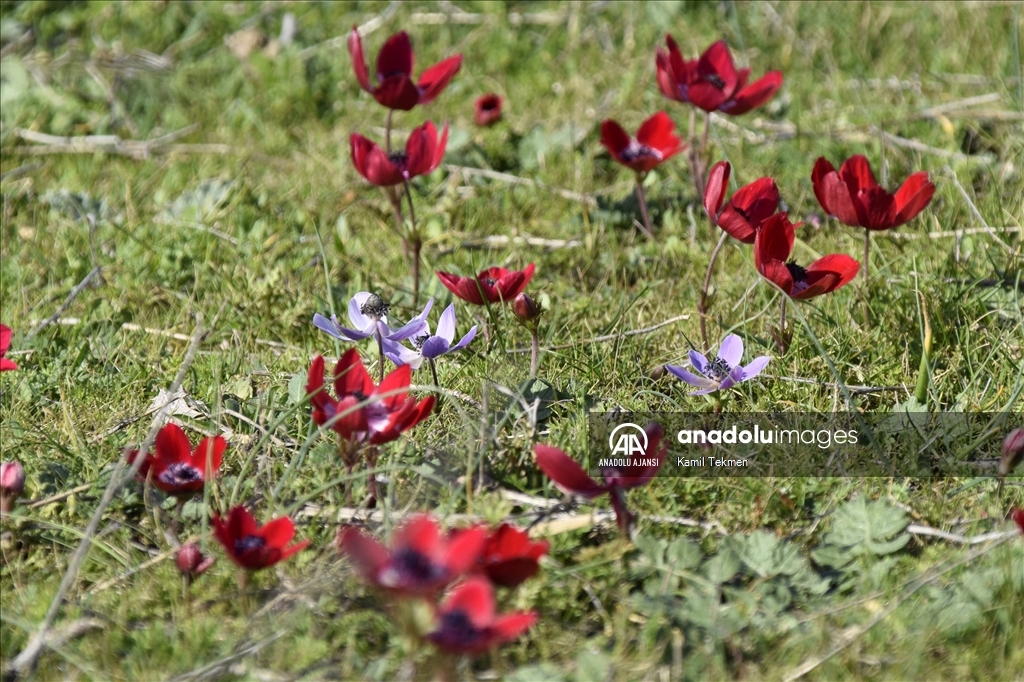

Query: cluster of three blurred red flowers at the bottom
[337,515,548,655]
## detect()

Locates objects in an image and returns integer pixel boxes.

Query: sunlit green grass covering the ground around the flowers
[0,2,1024,680]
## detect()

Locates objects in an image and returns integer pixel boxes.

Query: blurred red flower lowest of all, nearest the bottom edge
[427,578,537,655]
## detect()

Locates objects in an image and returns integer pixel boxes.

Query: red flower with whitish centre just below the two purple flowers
[306,348,435,444]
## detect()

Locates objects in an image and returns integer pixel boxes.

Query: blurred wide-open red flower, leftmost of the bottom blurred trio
[338,515,486,595]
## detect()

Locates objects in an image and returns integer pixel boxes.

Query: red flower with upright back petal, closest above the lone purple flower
[754,213,860,299]
